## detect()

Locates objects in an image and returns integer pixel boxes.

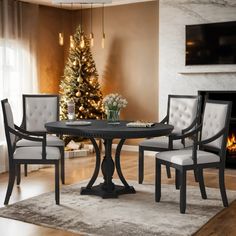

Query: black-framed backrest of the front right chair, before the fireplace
[200,100,232,152]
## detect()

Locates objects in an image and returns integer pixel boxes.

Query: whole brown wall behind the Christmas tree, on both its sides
[38,1,158,120]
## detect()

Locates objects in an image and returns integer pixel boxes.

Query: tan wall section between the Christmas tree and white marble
[83,1,158,120]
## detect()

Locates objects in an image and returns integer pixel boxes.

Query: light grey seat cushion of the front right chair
[156,149,220,166]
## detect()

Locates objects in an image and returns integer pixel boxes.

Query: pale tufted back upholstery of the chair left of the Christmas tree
[25,97,58,131]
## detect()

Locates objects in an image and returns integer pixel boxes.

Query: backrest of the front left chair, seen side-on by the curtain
[1,99,16,156]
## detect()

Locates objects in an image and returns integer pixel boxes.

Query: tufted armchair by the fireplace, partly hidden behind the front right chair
[138,95,201,184]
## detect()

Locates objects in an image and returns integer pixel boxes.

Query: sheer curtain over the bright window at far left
[0,0,38,172]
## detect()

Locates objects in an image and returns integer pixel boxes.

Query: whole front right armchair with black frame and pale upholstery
[155,100,231,213]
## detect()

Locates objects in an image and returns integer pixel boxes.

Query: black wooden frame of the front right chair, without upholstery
[155,100,232,213]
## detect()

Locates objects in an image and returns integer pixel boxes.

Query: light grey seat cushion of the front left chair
[14,146,61,160]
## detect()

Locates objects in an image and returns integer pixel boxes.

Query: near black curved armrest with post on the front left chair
[7,126,46,159]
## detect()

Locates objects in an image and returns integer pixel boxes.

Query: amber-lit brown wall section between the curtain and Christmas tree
[37,6,72,93]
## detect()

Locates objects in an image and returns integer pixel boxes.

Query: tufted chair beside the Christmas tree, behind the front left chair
[16,94,65,184]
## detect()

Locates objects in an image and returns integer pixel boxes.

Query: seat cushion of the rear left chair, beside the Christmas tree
[16,135,64,147]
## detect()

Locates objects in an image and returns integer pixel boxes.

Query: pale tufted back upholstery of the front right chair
[202,103,228,148]
